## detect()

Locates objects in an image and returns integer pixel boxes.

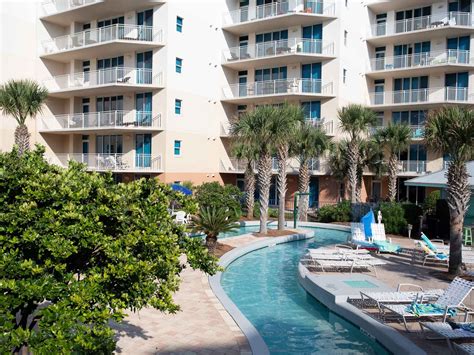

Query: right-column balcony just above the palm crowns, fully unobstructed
[370,87,474,108]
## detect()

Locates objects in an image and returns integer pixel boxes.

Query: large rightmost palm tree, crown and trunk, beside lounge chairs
[425,106,474,275]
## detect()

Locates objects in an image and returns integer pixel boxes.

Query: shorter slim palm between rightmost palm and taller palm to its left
[377,124,411,202]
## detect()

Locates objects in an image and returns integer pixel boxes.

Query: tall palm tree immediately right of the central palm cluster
[338,104,377,204]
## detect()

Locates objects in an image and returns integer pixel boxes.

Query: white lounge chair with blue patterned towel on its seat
[381,277,474,331]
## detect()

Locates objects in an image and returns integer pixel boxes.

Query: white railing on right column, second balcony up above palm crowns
[370,49,474,71]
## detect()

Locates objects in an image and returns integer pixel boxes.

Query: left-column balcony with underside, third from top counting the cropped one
[44,67,163,98]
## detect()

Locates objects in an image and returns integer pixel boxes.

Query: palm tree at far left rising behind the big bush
[0,79,48,155]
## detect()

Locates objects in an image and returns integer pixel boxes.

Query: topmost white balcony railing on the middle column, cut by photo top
[223,0,336,26]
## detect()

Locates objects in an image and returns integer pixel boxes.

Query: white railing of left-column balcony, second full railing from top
[44,67,163,92]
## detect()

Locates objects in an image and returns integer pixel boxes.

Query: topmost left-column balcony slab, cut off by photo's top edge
[40,0,166,27]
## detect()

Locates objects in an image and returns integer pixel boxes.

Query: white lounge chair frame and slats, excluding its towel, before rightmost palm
[381,277,474,331]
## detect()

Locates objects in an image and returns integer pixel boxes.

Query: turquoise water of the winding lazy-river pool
[222,228,388,355]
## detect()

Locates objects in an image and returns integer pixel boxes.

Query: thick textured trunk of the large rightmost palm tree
[446,160,471,275]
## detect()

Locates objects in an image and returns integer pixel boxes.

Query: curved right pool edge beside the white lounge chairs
[298,263,426,355]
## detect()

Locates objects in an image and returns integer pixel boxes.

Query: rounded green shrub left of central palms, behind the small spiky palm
[194,182,242,217]
